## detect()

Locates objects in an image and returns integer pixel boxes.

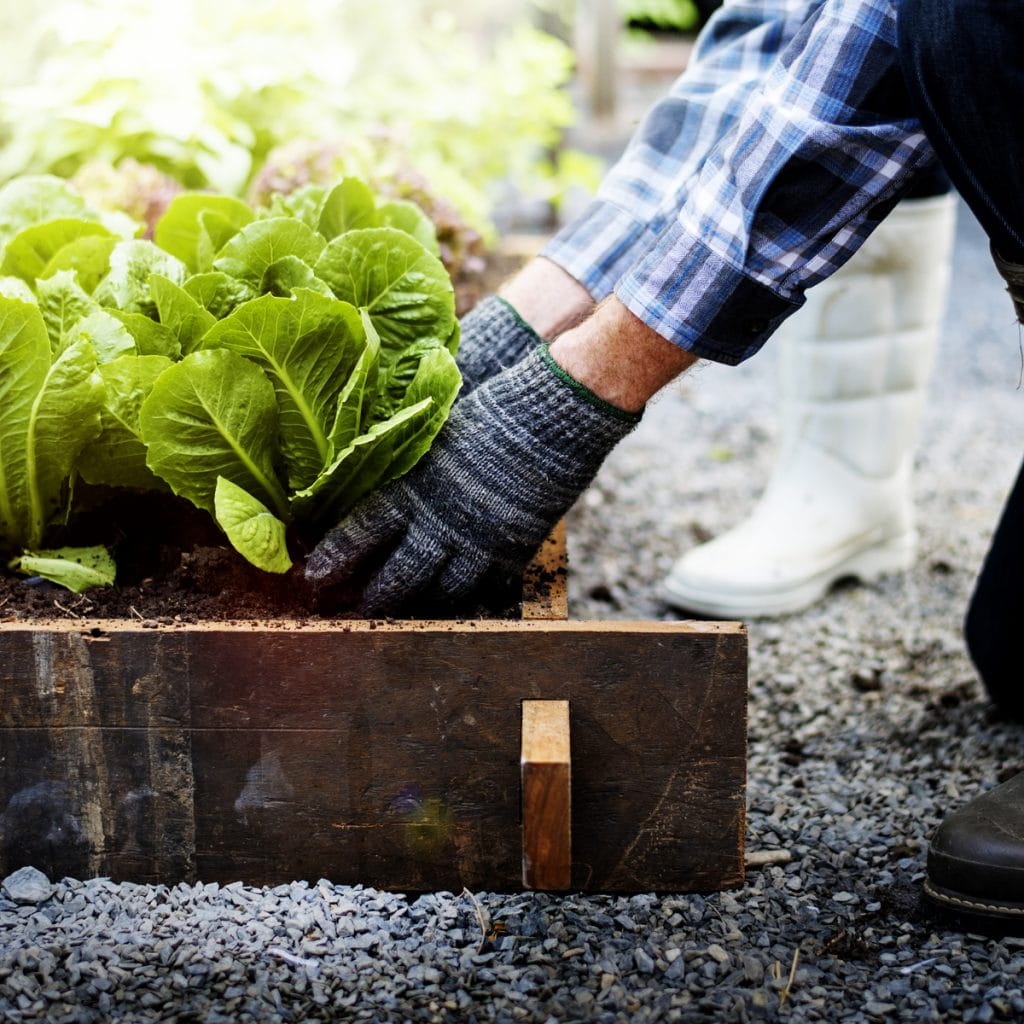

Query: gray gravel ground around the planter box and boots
[0,201,1024,1024]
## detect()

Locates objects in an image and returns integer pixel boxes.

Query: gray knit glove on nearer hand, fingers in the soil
[305,346,640,616]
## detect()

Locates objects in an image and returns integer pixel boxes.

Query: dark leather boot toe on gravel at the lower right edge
[925,772,1024,935]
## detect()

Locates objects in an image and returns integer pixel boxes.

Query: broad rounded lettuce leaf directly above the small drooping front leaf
[140,348,288,518]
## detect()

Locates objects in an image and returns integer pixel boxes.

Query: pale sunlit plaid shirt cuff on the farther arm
[541,199,657,302]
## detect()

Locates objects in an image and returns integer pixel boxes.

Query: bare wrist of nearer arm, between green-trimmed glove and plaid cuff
[551,297,696,413]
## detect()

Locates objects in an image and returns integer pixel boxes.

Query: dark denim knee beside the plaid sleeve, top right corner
[897,0,1024,263]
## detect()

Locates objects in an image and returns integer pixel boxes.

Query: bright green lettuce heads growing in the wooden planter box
[0,177,461,588]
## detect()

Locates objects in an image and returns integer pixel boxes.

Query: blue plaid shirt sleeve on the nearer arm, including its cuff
[614,0,935,364]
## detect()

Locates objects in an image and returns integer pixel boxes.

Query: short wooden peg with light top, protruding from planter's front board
[519,700,572,889]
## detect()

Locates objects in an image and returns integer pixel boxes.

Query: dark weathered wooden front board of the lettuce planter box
[0,542,746,892]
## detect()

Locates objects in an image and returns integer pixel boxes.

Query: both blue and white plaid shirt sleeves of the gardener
[544,0,935,364]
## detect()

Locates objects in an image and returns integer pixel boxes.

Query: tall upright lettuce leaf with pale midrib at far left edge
[0,299,102,550]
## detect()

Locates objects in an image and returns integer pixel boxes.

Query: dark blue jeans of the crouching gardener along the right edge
[897,0,1024,719]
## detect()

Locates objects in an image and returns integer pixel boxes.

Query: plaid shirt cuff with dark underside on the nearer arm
[615,222,804,366]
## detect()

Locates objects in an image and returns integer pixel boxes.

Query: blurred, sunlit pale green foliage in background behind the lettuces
[0,0,592,234]
